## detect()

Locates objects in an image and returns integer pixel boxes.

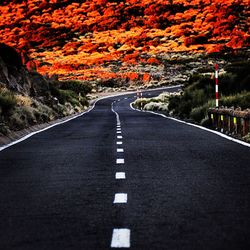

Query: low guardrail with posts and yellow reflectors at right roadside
[208,108,250,137]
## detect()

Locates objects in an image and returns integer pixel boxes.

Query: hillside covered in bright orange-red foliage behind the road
[0,0,249,82]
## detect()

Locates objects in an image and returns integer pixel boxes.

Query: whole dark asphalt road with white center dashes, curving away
[0,86,250,250]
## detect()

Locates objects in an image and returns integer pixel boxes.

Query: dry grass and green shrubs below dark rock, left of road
[0,80,91,135]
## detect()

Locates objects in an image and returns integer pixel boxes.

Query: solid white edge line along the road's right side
[130,102,250,148]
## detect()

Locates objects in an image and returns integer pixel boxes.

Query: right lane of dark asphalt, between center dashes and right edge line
[116,93,250,250]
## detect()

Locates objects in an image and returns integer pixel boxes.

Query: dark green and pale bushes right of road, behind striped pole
[134,61,250,126]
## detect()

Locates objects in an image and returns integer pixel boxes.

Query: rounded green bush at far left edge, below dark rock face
[0,89,17,115]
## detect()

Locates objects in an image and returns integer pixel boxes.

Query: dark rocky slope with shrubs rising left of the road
[0,43,91,136]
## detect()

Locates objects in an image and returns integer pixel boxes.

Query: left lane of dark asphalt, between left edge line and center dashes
[0,97,119,250]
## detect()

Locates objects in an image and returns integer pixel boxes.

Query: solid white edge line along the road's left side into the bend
[0,91,146,152]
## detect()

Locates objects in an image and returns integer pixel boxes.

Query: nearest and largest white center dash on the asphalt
[111,228,130,248]
